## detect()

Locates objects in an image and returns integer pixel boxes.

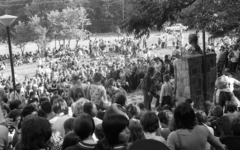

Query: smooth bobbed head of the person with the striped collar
[73,113,95,141]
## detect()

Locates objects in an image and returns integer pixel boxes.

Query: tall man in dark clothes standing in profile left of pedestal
[142,67,155,110]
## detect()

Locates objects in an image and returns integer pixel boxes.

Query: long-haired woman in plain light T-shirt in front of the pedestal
[167,103,225,150]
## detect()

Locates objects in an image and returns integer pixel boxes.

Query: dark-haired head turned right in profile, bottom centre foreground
[102,114,130,146]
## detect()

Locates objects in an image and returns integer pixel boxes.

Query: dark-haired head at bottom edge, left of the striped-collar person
[62,131,80,150]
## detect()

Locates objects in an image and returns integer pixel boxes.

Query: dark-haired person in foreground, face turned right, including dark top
[94,114,130,150]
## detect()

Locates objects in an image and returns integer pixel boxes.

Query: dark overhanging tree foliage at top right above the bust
[120,0,240,37]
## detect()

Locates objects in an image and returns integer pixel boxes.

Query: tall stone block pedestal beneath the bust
[175,53,217,110]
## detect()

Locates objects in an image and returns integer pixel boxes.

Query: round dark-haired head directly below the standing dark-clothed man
[140,112,159,133]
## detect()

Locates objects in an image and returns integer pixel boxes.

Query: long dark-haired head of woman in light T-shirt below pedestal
[174,102,196,129]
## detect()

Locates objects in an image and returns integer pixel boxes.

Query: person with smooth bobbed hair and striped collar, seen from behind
[66,113,96,150]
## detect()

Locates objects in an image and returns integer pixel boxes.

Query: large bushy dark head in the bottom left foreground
[21,116,52,150]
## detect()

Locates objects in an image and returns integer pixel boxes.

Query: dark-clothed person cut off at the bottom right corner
[219,118,240,150]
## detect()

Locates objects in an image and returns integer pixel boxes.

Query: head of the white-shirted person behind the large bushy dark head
[52,98,68,114]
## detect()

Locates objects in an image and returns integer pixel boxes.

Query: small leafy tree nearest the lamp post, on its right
[13,21,32,56]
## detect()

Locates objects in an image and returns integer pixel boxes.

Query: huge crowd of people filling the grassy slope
[0,34,240,150]
